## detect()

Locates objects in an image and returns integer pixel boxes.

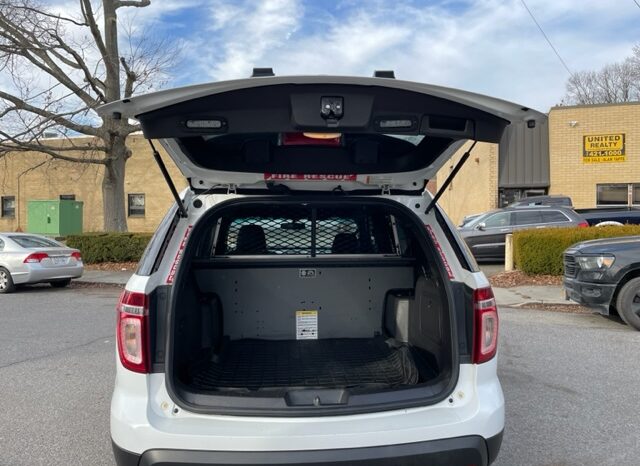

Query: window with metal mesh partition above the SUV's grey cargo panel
[212,206,399,256]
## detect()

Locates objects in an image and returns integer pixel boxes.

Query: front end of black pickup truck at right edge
[563,236,640,330]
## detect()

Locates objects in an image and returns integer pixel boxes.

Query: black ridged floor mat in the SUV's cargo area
[191,337,434,390]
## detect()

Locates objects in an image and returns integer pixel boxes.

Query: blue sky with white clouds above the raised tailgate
[43,0,640,111]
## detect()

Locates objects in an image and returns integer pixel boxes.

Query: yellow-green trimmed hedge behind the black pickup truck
[513,225,640,275]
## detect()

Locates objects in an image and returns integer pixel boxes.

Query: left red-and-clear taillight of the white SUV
[116,290,149,373]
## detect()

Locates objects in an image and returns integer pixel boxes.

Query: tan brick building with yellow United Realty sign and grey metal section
[437,102,640,226]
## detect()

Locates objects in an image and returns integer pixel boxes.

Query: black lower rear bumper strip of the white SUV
[113,432,502,466]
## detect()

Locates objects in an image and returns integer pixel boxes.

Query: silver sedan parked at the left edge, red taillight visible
[0,233,84,293]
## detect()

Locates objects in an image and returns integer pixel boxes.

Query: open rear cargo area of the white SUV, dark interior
[170,200,452,407]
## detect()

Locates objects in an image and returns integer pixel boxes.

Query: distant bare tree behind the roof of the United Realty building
[562,45,640,105]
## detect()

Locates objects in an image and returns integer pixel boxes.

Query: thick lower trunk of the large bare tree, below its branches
[102,136,129,231]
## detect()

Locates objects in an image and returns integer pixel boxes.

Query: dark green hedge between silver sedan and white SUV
[65,233,151,264]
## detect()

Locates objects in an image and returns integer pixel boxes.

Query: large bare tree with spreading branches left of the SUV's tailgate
[0,0,175,231]
